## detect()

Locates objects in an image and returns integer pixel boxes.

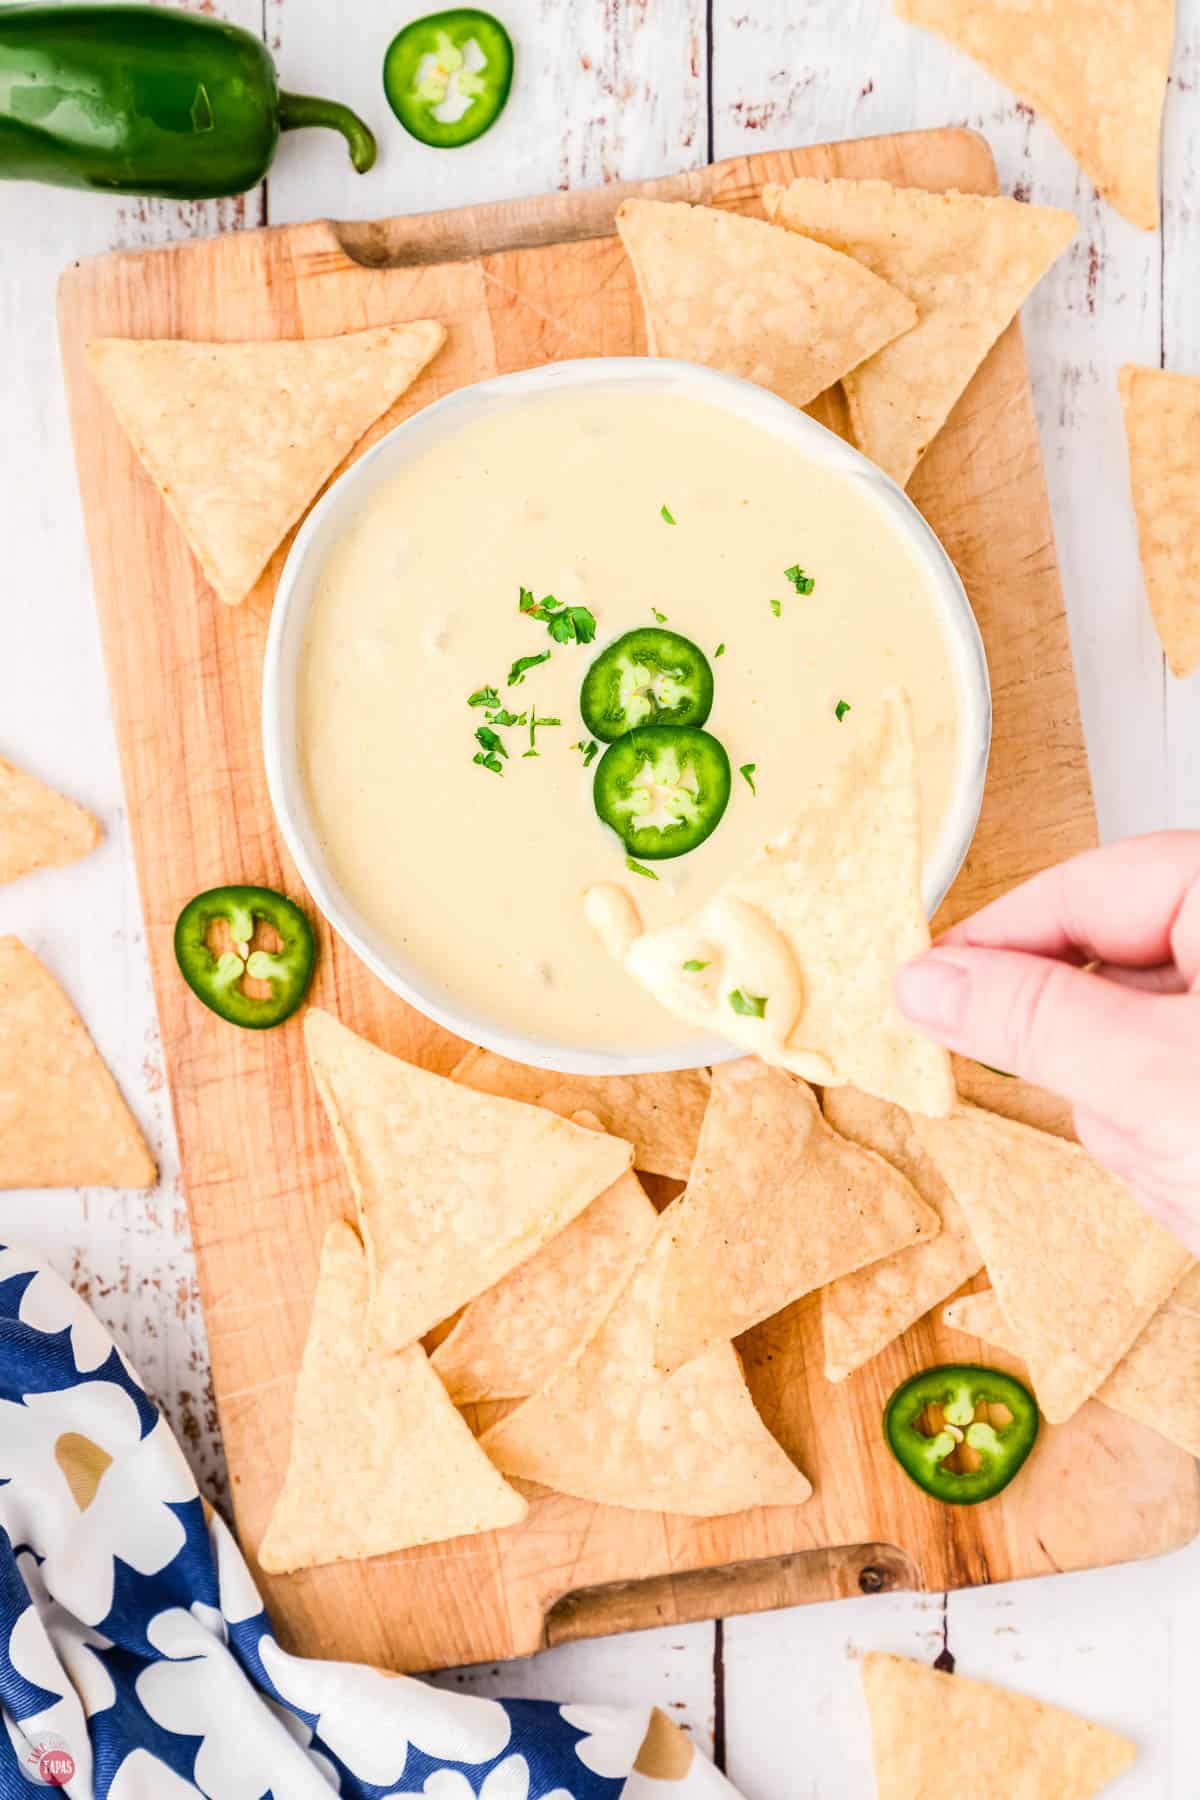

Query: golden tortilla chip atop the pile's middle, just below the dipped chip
[655,1057,937,1372]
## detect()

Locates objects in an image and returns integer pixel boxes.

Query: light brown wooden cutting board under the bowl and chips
[59,130,1200,1669]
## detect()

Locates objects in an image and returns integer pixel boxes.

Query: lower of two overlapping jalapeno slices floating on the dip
[592,725,730,862]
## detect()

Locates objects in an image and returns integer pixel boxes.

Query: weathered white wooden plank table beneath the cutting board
[0,0,1200,1800]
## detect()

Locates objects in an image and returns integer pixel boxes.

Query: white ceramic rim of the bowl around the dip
[263,356,991,1075]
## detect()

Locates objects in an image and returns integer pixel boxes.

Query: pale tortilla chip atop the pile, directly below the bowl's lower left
[304,1008,633,1348]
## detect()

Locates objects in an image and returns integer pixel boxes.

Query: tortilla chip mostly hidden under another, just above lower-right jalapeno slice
[943,1264,1200,1456]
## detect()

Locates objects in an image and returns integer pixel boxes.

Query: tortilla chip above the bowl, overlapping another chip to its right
[617,200,918,407]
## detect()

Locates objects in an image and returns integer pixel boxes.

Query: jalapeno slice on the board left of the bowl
[175,887,317,1031]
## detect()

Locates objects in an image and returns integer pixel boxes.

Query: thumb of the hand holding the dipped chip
[896,947,1196,1120]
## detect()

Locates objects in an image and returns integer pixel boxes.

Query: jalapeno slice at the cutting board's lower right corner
[883,1363,1038,1507]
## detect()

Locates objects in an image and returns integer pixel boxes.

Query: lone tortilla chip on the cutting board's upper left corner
[86,319,446,607]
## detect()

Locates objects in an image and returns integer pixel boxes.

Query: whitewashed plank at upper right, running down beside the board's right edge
[714,0,1165,837]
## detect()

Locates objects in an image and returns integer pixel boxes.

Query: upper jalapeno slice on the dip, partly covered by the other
[579,625,712,743]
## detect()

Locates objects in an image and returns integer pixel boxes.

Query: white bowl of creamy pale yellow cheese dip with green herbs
[263,356,991,1075]
